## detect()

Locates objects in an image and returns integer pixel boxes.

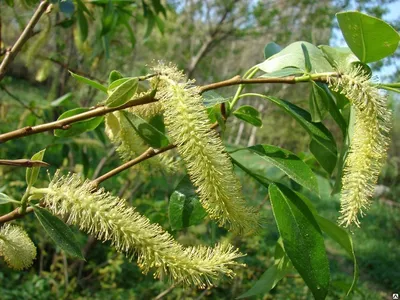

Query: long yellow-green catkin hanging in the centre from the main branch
[154,64,259,233]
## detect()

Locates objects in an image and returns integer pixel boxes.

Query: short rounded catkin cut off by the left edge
[0,224,36,270]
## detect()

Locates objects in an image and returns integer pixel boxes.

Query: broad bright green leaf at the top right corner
[336,11,400,63]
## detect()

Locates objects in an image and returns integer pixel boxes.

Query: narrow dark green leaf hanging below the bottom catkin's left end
[33,206,85,260]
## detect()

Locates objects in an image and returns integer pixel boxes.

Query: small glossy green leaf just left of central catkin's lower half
[168,176,207,230]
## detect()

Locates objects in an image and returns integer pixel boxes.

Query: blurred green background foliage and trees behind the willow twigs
[0,0,400,299]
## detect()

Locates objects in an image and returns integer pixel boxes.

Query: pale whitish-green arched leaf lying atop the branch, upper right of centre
[257,42,333,73]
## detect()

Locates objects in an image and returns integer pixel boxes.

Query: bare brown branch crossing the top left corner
[0,0,50,81]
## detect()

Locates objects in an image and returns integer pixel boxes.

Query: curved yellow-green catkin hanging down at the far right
[329,68,391,227]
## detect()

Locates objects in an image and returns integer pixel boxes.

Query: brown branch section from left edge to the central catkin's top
[0,95,157,144]
